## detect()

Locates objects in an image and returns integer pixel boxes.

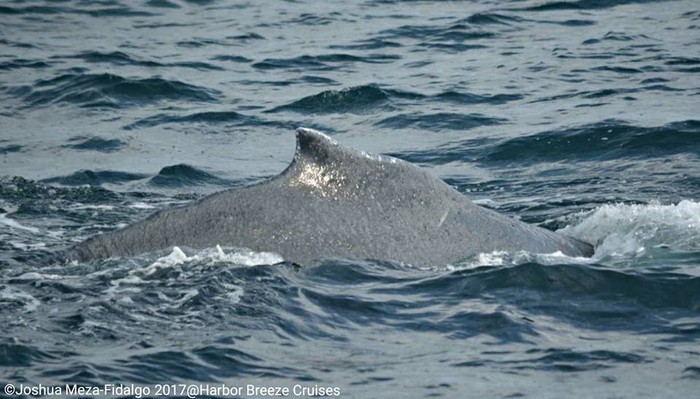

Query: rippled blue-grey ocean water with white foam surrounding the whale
[0,0,700,398]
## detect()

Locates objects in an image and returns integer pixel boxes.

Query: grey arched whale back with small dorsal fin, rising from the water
[67,128,593,266]
